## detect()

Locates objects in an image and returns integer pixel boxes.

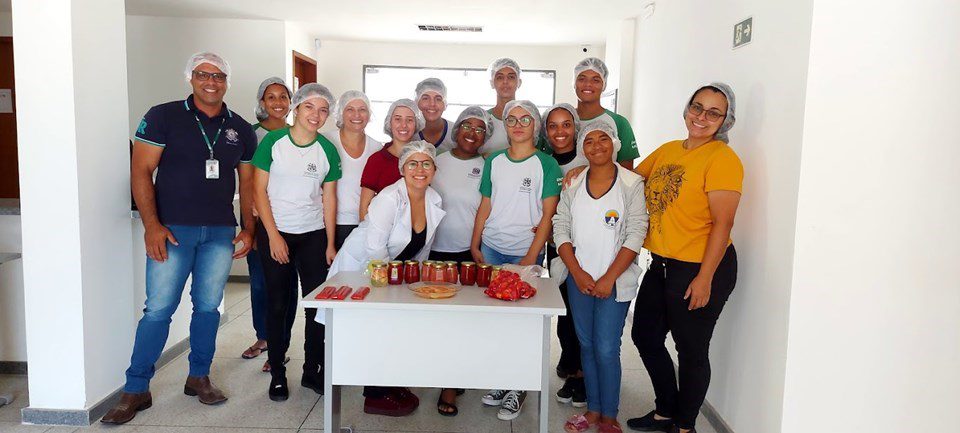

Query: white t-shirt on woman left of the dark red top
[323,130,383,225]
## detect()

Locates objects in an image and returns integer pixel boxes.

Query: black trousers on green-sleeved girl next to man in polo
[257,224,327,383]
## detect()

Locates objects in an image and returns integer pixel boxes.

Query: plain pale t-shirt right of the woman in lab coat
[430,152,483,253]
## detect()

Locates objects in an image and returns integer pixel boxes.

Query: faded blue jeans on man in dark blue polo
[123,226,236,393]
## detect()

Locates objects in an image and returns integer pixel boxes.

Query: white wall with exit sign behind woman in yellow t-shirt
[628,0,812,433]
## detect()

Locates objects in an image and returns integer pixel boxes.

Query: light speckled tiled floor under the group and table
[0,283,715,433]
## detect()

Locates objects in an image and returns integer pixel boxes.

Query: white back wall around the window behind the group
[316,40,604,130]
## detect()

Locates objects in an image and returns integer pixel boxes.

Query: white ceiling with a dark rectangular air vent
[120,0,652,45]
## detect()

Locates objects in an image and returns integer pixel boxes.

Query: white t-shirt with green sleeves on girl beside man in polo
[252,128,341,234]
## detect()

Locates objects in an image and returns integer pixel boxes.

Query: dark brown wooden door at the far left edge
[0,37,20,198]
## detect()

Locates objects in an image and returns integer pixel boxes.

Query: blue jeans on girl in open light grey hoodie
[567,276,630,418]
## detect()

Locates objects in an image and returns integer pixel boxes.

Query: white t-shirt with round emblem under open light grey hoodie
[570,173,626,280]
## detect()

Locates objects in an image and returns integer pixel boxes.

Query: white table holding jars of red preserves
[302,272,566,433]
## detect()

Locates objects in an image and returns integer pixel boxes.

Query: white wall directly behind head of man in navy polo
[127,16,288,135]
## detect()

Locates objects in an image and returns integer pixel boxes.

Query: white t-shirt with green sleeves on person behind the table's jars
[480,149,563,256]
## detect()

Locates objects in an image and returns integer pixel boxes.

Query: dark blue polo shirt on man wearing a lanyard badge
[134,95,257,226]
